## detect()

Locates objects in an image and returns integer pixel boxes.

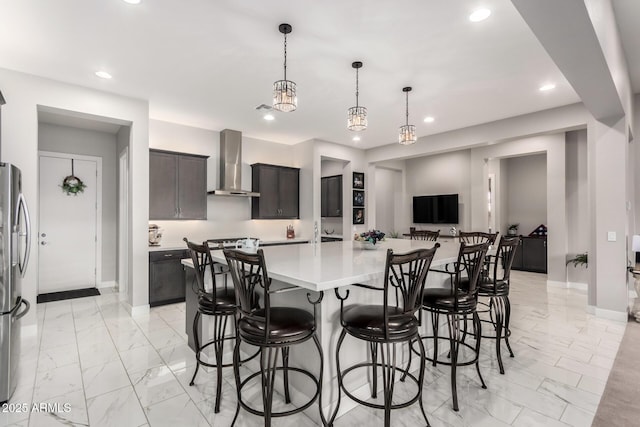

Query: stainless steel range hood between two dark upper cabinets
[208,129,260,197]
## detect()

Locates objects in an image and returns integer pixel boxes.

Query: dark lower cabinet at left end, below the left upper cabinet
[149,249,189,307]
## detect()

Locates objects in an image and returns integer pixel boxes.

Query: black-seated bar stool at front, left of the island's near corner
[224,249,327,427]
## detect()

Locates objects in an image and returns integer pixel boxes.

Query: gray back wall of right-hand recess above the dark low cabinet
[505,154,548,235]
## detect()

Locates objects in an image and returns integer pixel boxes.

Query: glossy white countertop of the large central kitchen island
[182,239,459,291]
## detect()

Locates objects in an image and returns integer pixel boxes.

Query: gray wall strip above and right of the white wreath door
[38,123,118,286]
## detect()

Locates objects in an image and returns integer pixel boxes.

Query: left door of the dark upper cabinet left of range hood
[149,151,178,219]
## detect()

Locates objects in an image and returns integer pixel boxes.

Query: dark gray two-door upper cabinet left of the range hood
[149,150,207,220]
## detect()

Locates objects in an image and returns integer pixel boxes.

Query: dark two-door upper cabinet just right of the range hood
[251,163,300,219]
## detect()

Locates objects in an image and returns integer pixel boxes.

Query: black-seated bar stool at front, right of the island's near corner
[329,247,440,427]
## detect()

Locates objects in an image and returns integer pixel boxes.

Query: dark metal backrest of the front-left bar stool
[224,249,271,340]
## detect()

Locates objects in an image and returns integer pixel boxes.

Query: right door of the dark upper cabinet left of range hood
[178,156,207,219]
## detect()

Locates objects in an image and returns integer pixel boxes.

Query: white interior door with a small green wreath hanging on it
[38,155,98,294]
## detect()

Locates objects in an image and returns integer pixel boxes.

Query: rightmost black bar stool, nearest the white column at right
[478,236,520,374]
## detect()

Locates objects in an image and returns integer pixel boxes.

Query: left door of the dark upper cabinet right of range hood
[251,164,280,219]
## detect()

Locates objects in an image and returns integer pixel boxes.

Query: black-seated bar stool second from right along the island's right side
[421,242,489,411]
